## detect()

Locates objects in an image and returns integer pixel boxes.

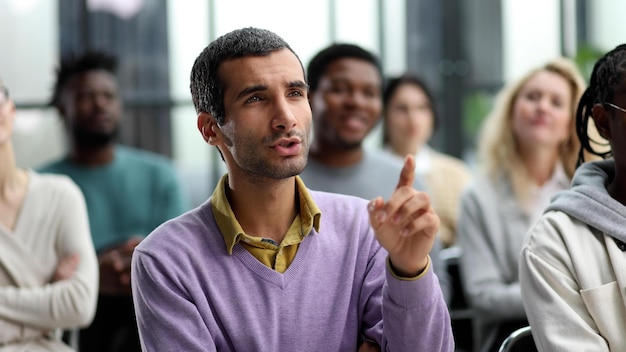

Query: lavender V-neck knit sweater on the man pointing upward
[132,191,454,352]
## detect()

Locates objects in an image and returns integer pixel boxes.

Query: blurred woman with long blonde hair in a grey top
[458,58,585,351]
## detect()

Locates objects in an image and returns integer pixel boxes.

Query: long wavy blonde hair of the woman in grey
[478,58,586,204]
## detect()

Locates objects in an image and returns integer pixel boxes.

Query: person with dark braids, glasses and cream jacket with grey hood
[520,44,626,352]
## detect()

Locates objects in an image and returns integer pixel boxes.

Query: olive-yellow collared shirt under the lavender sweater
[211,174,322,273]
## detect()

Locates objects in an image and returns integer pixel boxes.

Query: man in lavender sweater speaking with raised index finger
[132,28,454,352]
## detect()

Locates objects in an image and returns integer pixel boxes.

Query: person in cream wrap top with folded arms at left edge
[0,81,98,352]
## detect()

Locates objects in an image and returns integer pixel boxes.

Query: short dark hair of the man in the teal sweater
[50,50,117,108]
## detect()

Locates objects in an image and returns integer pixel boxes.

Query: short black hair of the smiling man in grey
[307,44,383,92]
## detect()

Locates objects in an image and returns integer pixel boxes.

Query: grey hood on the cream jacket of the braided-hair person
[545,159,626,242]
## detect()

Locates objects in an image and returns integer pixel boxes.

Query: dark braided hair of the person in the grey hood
[576,44,626,166]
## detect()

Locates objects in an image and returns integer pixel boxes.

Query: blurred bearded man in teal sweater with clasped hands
[41,51,186,352]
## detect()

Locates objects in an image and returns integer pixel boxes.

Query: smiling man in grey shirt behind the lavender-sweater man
[300,44,452,302]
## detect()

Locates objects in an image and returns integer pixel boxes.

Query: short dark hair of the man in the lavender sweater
[190,27,304,124]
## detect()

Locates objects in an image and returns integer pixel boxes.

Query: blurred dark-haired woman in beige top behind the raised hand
[383,73,471,247]
